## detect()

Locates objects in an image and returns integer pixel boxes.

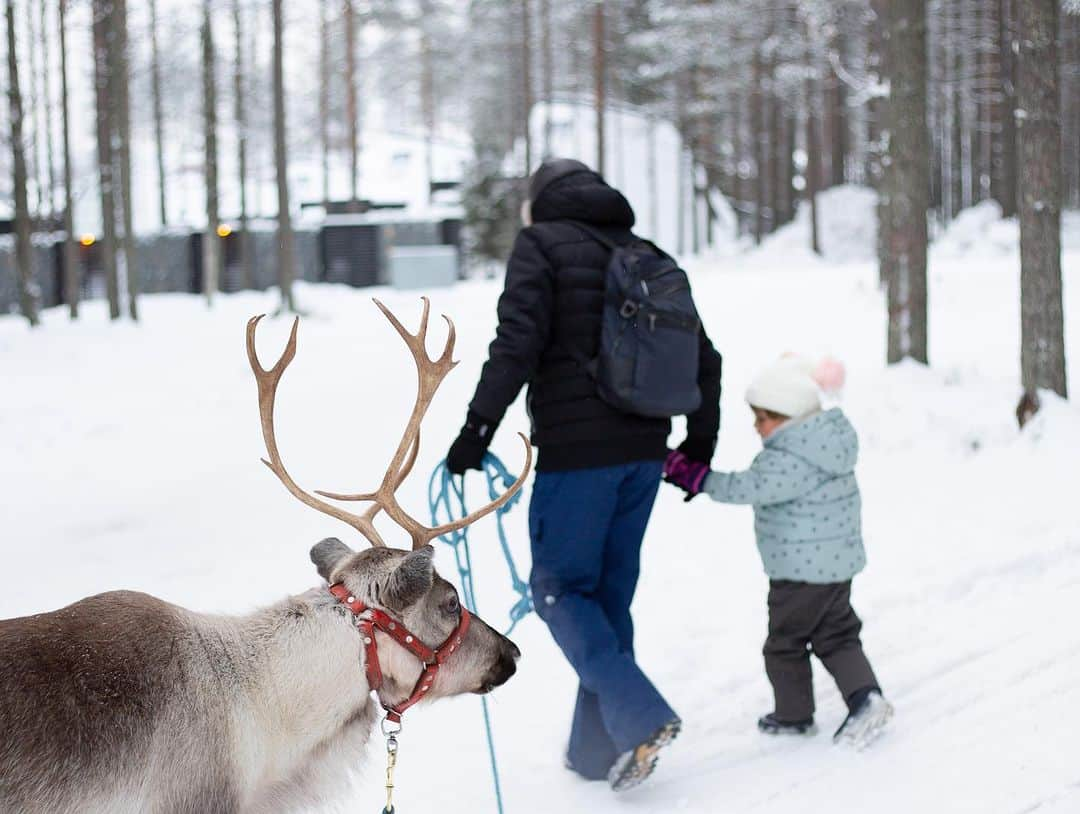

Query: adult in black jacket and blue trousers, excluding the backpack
[446,159,720,790]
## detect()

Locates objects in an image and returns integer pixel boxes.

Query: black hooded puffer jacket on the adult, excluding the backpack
[469,172,720,471]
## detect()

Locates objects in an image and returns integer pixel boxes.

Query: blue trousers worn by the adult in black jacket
[529,461,676,779]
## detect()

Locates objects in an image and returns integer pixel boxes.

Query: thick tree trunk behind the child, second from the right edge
[886,0,930,364]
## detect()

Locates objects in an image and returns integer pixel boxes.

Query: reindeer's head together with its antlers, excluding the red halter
[247,298,532,702]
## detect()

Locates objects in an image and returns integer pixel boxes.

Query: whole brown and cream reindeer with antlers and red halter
[0,299,532,814]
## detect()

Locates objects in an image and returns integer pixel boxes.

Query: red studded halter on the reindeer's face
[330,582,472,723]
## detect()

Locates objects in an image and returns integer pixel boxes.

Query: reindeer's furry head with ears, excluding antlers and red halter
[311,538,521,703]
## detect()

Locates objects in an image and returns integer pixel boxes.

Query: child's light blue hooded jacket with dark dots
[705,409,866,583]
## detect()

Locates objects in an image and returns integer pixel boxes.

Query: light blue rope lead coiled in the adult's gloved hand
[428,452,532,814]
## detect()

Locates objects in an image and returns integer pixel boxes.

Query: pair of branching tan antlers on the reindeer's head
[247,297,532,548]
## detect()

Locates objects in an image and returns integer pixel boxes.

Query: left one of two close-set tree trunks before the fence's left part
[92,0,120,320]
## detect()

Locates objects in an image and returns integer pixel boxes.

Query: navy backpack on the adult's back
[571,221,701,418]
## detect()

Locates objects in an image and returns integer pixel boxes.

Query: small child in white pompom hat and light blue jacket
[664,356,892,748]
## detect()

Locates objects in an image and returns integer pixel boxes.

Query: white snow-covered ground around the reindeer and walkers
[0,210,1080,814]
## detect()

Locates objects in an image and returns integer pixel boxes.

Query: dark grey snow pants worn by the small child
[764,580,878,721]
